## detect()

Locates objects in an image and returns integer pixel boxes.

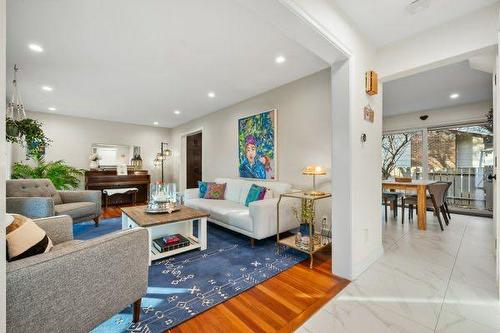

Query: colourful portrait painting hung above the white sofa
[238,110,277,180]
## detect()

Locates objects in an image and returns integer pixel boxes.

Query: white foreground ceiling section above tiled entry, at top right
[333,0,498,47]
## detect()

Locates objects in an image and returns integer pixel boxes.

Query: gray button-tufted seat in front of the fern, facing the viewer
[6,179,102,226]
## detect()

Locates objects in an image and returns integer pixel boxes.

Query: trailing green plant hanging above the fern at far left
[6,117,52,158]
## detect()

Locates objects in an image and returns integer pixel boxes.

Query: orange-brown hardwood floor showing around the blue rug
[101,207,349,333]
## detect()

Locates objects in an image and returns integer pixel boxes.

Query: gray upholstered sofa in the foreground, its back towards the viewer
[7,216,149,333]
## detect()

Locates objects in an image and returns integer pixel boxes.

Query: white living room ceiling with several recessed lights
[7,0,328,127]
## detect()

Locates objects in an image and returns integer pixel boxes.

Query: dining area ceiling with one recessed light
[383,60,493,117]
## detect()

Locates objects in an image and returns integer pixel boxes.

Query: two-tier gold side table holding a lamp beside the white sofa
[276,191,332,268]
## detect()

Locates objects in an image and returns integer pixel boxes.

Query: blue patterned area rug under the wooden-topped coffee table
[74,218,307,333]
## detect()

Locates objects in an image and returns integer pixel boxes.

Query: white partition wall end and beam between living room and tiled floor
[286,0,383,279]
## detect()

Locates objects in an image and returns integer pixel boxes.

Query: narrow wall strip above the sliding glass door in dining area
[383,101,492,132]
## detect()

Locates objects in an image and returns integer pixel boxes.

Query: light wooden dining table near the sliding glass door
[382,179,437,230]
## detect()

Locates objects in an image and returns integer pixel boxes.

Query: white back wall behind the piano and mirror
[12,112,170,186]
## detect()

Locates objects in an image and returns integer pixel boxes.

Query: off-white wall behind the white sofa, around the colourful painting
[172,69,332,216]
